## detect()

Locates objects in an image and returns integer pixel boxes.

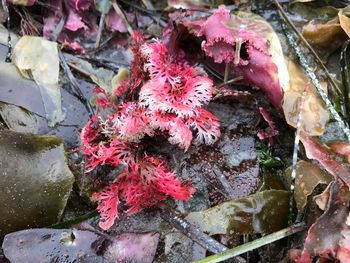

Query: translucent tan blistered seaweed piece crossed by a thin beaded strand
[283,61,329,136]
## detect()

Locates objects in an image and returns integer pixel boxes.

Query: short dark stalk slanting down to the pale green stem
[158,204,245,263]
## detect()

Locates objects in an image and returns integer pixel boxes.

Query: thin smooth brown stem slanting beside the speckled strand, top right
[273,0,342,96]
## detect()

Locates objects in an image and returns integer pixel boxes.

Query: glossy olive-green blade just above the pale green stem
[186,190,289,235]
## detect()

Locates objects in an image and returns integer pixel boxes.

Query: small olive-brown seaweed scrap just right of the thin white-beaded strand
[287,161,332,211]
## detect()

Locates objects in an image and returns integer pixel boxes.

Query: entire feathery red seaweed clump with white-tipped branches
[81,33,220,229]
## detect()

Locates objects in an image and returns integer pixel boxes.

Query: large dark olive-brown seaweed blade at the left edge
[0,131,74,238]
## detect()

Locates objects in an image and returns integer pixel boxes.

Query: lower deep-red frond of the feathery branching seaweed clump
[92,155,195,230]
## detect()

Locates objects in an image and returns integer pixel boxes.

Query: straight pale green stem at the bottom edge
[195,224,306,263]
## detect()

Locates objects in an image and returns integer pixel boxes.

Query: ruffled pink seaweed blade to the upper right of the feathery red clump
[175,5,283,110]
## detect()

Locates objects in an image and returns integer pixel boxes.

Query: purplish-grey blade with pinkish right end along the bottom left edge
[3,228,159,263]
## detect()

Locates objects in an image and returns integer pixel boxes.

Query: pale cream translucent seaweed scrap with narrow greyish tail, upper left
[12,36,64,126]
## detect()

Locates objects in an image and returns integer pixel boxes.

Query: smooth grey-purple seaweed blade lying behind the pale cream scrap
[0,63,92,147]
